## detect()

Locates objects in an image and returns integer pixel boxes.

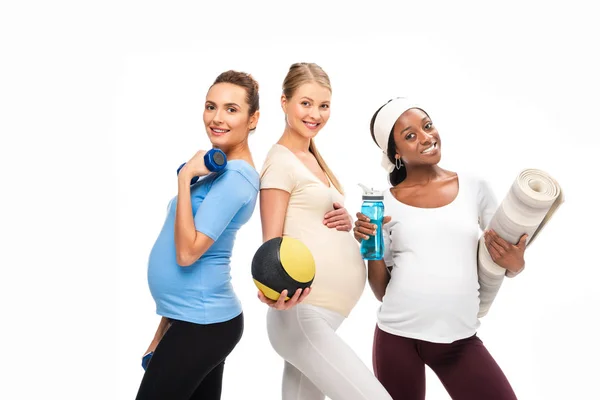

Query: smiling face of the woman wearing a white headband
[394,108,442,166]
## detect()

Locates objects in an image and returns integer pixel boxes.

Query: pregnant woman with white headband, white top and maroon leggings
[354,98,527,400]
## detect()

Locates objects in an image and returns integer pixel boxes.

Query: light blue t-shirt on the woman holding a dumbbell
[148,160,259,324]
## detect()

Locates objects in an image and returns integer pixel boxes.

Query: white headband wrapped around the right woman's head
[373,97,423,173]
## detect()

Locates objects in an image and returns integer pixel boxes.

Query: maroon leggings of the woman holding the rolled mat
[373,327,517,400]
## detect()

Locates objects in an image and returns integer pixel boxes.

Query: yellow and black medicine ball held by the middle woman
[252,236,315,300]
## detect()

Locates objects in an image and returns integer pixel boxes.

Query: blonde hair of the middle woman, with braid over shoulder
[283,63,344,194]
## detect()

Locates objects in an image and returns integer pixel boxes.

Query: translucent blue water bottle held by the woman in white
[360,184,384,260]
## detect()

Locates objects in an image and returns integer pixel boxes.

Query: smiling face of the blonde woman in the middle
[281,82,331,139]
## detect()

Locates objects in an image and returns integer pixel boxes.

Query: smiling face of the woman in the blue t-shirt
[203,83,258,151]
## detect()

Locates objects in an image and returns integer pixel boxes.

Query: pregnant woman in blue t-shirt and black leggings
[137,71,259,400]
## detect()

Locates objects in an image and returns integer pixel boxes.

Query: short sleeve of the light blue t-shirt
[194,170,258,241]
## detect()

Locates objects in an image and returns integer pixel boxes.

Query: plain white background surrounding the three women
[0,1,600,400]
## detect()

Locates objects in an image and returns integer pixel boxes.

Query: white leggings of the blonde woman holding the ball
[267,304,392,400]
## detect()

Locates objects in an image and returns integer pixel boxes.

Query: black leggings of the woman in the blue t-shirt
[136,314,244,400]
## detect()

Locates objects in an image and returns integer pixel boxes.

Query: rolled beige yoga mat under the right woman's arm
[477,169,564,317]
